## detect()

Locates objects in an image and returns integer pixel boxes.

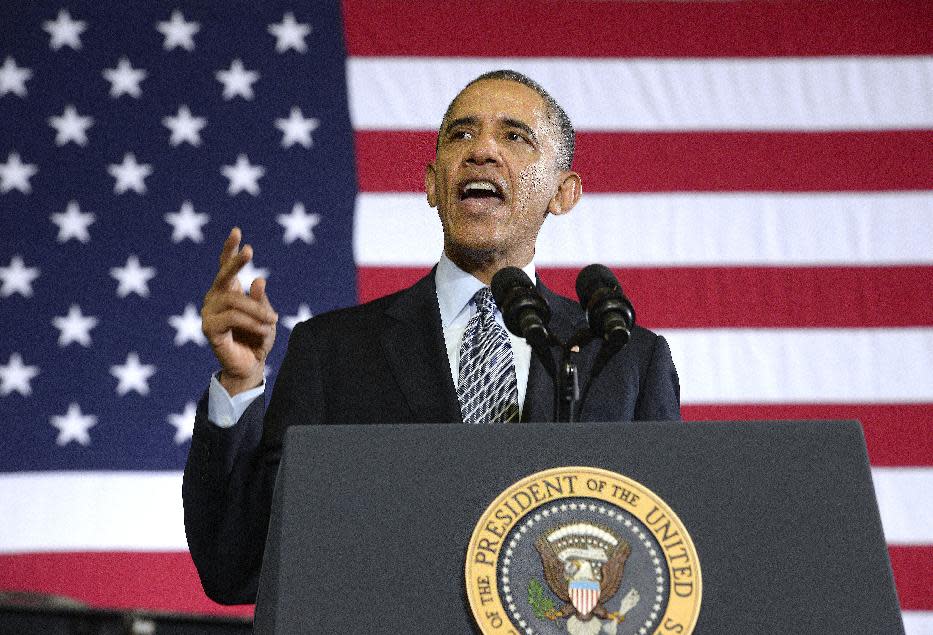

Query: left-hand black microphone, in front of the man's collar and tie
[490,267,551,350]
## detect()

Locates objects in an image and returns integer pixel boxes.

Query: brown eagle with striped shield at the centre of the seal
[535,536,632,621]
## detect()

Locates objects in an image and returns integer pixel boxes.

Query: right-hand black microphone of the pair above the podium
[577,265,635,349]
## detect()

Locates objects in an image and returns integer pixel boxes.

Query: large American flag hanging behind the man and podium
[0,0,933,634]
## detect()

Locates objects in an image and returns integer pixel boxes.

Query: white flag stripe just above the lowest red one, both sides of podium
[0,467,933,553]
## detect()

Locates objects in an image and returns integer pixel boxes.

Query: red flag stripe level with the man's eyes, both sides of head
[356,132,933,192]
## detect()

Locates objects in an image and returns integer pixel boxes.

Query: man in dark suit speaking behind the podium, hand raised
[183,71,680,603]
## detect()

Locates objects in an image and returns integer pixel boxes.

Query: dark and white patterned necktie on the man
[457,287,518,423]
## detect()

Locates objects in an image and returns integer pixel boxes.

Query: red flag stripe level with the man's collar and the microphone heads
[357,266,933,328]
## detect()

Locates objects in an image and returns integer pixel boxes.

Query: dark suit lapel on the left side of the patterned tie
[382,269,463,423]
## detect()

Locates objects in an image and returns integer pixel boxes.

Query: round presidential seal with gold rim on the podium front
[466,467,701,635]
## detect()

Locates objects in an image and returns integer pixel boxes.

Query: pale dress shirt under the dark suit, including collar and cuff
[207,254,535,428]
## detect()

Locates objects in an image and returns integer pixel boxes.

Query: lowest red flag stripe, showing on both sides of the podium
[0,546,933,617]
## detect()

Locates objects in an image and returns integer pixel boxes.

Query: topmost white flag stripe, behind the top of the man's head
[347,56,933,130]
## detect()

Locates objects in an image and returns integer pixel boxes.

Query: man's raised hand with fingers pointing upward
[201,227,279,395]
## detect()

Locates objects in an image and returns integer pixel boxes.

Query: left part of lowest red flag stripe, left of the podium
[0,552,253,617]
